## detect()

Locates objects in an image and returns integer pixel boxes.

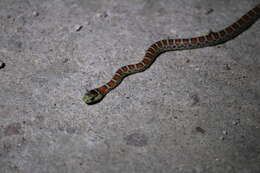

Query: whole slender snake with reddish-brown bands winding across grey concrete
[82,4,260,105]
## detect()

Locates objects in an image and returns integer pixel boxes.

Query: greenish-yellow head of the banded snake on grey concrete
[82,89,104,105]
